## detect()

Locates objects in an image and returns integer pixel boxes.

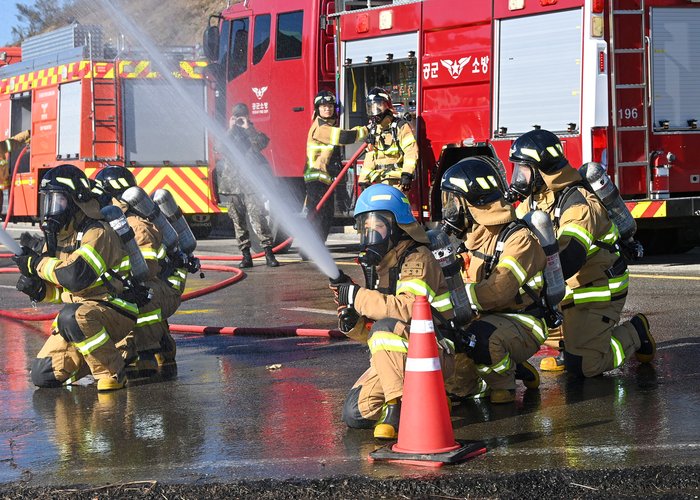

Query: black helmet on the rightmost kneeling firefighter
[509,129,567,174]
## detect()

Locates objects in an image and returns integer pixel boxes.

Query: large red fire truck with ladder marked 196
[204,0,700,252]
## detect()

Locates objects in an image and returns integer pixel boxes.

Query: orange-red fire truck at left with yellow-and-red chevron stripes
[0,24,221,236]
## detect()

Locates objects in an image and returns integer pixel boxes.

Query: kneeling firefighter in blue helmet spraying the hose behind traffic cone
[330,184,454,439]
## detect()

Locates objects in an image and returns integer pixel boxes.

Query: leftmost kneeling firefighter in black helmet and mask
[13,165,144,391]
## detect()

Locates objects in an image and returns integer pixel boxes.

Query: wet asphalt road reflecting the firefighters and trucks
[0,225,700,498]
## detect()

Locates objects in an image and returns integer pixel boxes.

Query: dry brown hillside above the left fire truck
[13,0,241,49]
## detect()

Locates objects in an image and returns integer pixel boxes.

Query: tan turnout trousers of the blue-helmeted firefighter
[343,318,454,429]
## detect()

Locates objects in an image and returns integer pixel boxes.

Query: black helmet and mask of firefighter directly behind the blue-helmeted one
[440,156,505,238]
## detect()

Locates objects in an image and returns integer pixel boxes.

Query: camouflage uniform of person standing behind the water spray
[218,124,274,250]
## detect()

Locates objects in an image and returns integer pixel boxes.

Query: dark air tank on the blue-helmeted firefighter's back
[427,229,472,326]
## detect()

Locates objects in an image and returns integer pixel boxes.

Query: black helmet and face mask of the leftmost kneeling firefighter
[39,165,95,234]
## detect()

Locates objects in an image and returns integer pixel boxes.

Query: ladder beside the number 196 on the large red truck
[610,0,651,198]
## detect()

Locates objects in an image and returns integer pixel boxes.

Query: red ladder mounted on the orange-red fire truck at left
[88,33,123,161]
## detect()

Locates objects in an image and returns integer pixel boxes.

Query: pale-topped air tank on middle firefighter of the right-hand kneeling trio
[523,210,566,308]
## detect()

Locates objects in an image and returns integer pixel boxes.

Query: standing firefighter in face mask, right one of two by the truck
[357,87,418,193]
